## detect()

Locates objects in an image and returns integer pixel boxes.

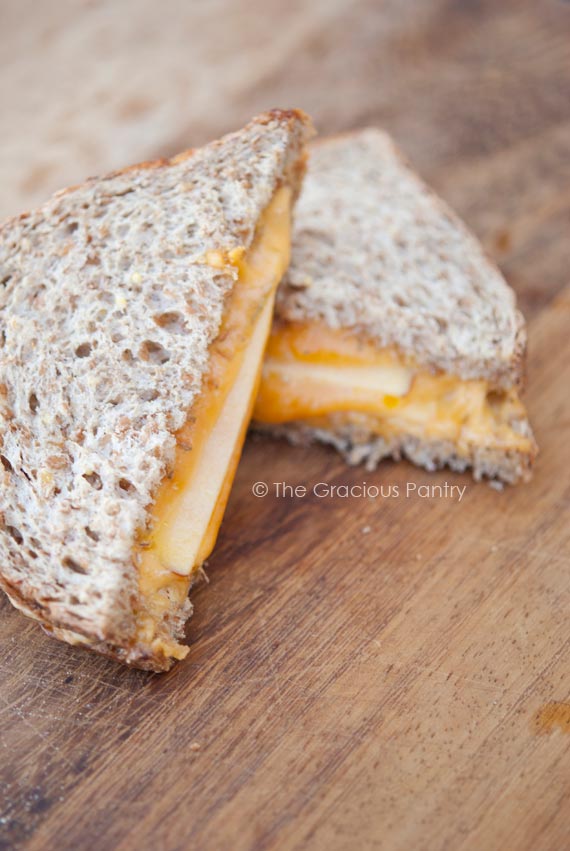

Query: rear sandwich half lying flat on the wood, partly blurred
[254,129,536,483]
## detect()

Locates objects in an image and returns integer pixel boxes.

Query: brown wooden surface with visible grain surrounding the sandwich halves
[0,0,570,851]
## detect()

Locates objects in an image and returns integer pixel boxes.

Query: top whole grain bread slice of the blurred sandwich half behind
[276,128,526,388]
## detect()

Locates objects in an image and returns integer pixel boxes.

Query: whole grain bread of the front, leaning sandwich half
[0,110,310,670]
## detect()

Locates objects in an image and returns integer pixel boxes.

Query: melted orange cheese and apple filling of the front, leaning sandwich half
[136,187,292,659]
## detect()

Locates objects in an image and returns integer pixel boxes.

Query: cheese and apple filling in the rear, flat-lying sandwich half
[253,322,531,457]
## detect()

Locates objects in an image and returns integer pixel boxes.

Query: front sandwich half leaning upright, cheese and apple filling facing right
[0,111,311,671]
